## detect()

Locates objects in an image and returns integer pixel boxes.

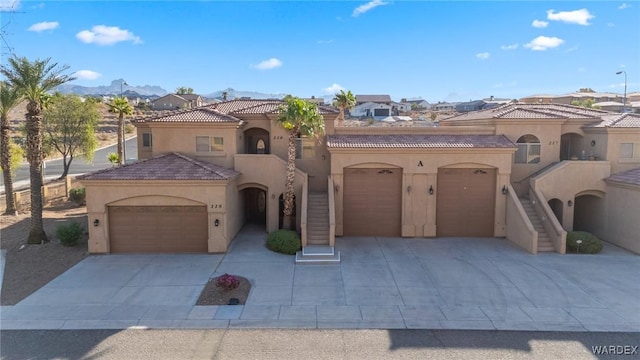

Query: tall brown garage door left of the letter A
[344,169,402,236]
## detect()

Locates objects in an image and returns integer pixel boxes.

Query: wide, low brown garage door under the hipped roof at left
[109,206,208,253]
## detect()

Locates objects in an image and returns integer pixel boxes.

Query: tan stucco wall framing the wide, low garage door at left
[81,180,231,253]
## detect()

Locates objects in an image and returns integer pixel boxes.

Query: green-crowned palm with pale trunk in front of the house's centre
[277,95,324,230]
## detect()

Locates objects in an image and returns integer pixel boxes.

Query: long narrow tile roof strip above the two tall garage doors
[327,135,516,149]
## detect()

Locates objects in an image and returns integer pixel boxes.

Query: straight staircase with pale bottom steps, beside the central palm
[296,192,340,264]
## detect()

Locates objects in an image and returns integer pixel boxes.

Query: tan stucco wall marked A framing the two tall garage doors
[330,149,513,237]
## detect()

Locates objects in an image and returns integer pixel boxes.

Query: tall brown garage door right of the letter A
[436,169,496,237]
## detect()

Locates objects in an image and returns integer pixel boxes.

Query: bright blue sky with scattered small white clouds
[0,0,640,102]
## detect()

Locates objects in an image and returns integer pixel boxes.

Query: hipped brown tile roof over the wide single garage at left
[78,153,240,180]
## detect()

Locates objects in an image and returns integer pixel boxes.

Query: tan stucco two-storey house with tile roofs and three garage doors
[81,100,640,253]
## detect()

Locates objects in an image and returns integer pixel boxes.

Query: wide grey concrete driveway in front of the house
[1,226,640,332]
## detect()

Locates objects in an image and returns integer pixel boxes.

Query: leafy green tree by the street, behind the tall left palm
[43,94,100,179]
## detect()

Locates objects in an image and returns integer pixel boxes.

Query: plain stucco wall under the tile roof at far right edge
[597,183,640,254]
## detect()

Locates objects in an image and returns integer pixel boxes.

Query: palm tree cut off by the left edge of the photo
[0,81,20,215]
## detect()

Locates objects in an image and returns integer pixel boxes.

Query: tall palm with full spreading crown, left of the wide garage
[0,55,75,244]
